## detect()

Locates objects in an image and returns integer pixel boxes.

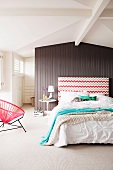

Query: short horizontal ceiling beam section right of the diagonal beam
[99,9,113,19]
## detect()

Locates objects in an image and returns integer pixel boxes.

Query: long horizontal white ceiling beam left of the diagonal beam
[0,8,92,17]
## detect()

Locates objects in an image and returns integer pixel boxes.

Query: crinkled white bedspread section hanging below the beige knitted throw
[54,120,113,147]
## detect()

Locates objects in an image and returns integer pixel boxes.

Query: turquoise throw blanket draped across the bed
[40,108,113,145]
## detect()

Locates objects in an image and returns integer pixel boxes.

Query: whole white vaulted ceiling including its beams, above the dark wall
[0,0,113,57]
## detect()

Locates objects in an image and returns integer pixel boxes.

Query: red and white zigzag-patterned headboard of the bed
[58,77,109,101]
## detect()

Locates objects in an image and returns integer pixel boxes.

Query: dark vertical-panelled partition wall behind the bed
[35,42,113,109]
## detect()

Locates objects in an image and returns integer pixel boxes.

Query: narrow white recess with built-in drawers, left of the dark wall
[24,57,35,103]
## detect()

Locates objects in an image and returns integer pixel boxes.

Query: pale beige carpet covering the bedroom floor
[0,105,113,170]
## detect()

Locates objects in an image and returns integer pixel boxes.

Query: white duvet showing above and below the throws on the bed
[48,96,113,147]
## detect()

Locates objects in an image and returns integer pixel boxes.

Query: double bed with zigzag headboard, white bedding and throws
[40,77,113,147]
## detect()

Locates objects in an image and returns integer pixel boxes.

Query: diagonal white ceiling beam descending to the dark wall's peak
[75,0,110,45]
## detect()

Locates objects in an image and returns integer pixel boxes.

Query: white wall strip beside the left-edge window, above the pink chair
[0,52,12,102]
